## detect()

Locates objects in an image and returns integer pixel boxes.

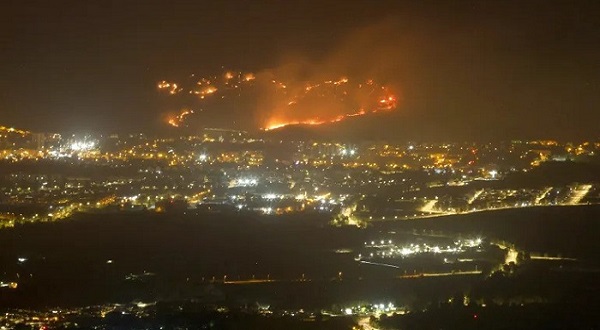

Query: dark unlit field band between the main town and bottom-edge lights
[0,206,600,307]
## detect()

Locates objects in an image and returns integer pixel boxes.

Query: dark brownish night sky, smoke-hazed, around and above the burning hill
[0,0,600,139]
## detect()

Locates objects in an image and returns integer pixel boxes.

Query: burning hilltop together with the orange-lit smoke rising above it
[157,22,412,129]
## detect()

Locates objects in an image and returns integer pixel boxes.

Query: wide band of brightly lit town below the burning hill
[0,127,600,227]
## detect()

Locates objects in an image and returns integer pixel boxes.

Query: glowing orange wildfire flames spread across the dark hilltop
[158,71,398,130]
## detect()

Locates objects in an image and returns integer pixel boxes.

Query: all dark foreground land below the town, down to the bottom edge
[0,206,600,329]
